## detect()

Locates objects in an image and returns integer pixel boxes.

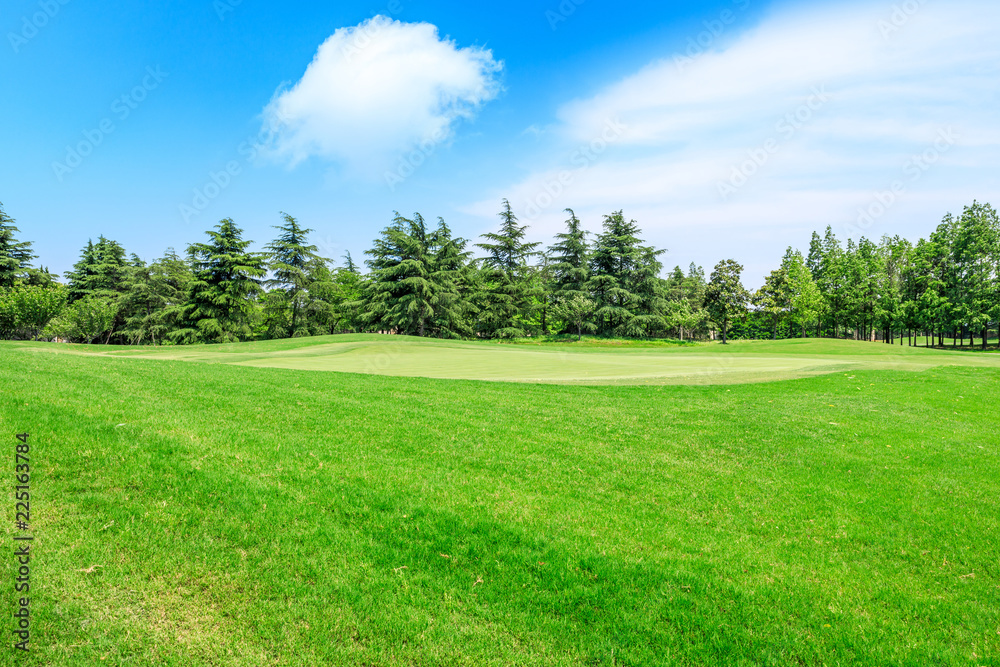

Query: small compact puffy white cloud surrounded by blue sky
[264,16,503,171]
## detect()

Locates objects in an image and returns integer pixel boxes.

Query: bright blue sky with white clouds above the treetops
[0,0,1000,285]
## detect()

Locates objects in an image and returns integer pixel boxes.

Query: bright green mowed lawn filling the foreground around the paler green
[0,340,1000,667]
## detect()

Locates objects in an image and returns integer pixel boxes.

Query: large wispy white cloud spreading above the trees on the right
[467,0,1000,284]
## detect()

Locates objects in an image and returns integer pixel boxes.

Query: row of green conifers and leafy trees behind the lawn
[0,200,1000,347]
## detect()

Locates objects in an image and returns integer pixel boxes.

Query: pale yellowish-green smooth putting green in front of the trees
[13,335,1000,384]
